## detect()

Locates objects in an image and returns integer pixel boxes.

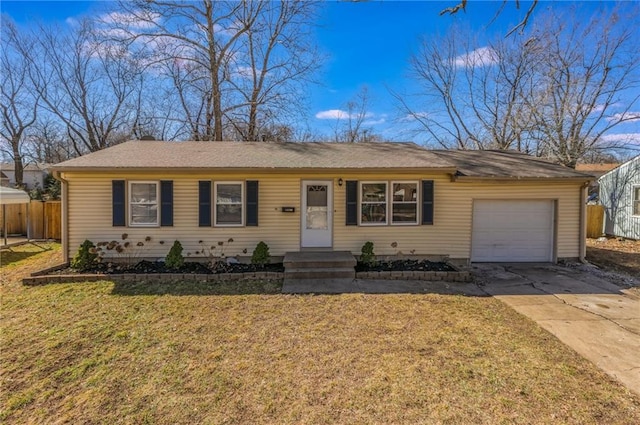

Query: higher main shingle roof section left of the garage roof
[53,141,453,170]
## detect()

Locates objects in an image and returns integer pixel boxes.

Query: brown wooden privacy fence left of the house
[0,201,62,239]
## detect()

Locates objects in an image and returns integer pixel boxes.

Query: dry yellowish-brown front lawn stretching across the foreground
[0,243,640,424]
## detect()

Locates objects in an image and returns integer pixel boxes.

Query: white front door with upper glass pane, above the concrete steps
[300,180,333,248]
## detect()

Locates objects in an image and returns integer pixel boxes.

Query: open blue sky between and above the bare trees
[0,0,640,146]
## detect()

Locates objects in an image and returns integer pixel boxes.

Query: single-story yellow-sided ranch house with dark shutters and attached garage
[51,141,591,263]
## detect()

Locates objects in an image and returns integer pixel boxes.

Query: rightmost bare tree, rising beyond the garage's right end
[527,8,640,167]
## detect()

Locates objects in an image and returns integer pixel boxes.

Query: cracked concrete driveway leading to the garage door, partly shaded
[474,264,640,395]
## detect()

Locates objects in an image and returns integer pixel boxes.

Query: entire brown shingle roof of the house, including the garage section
[52,141,590,179]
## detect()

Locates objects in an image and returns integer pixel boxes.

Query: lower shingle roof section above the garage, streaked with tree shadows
[433,150,592,180]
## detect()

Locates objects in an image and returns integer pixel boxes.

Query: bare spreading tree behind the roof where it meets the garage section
[395,28,538,151]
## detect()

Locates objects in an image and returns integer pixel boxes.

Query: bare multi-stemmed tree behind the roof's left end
[14,20,142,155]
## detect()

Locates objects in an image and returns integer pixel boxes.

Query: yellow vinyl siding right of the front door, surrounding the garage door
[334,175,580,259]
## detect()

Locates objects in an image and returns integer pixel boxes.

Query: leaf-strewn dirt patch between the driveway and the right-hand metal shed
[587,238,640,278]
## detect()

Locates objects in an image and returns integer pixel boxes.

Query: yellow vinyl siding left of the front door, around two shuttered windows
[65,174,300,258]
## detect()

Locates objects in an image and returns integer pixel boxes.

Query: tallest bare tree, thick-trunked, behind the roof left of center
[112,0,318,140]
